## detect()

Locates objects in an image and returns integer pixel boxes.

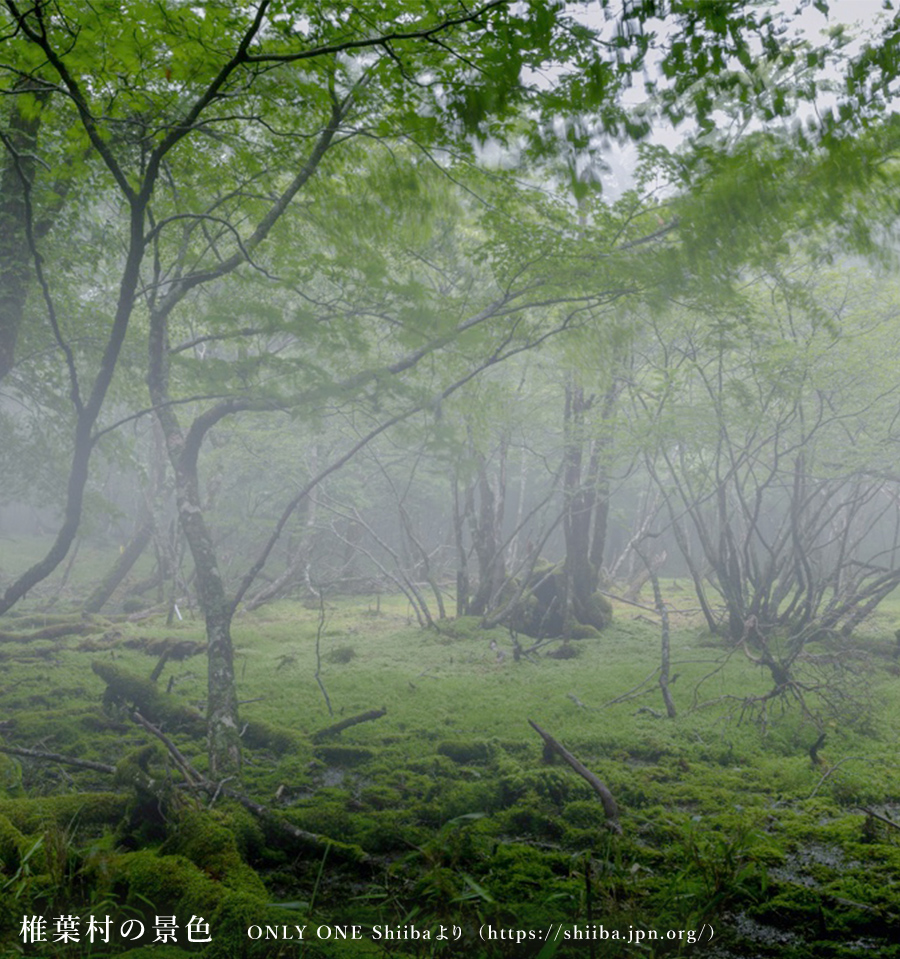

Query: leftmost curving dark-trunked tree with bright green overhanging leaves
[8,0,893,610]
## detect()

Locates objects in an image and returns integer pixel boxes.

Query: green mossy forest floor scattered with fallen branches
[0,568,900,959]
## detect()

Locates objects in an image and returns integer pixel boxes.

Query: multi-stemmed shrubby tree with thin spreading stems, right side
[633,266,900,690]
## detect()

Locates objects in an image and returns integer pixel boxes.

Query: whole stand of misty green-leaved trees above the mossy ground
[0,0,896,777]
